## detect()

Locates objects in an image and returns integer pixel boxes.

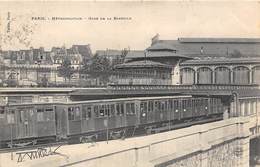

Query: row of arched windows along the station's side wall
[180,66,260,84]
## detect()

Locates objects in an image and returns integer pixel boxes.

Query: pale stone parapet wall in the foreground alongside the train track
[7,117,251,167]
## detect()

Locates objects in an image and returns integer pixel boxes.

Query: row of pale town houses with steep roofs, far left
[0,45,92,86]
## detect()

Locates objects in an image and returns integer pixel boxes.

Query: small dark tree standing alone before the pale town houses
[58,58,74,82]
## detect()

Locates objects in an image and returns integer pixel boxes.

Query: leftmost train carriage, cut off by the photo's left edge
[0,104,56,145]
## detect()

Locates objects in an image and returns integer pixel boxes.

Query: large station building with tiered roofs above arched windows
[121,36,260,85]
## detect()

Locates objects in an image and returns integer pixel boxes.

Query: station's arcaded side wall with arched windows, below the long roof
[180,58,260,85]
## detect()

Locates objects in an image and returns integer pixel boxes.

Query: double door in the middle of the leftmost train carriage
[17,108,36,138]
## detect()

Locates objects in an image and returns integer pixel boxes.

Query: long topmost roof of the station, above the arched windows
[156,38,260,58]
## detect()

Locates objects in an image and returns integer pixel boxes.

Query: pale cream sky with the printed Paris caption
[0,1,260,51]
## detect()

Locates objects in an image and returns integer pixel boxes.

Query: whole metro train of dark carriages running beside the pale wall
[0,95,229,147]
